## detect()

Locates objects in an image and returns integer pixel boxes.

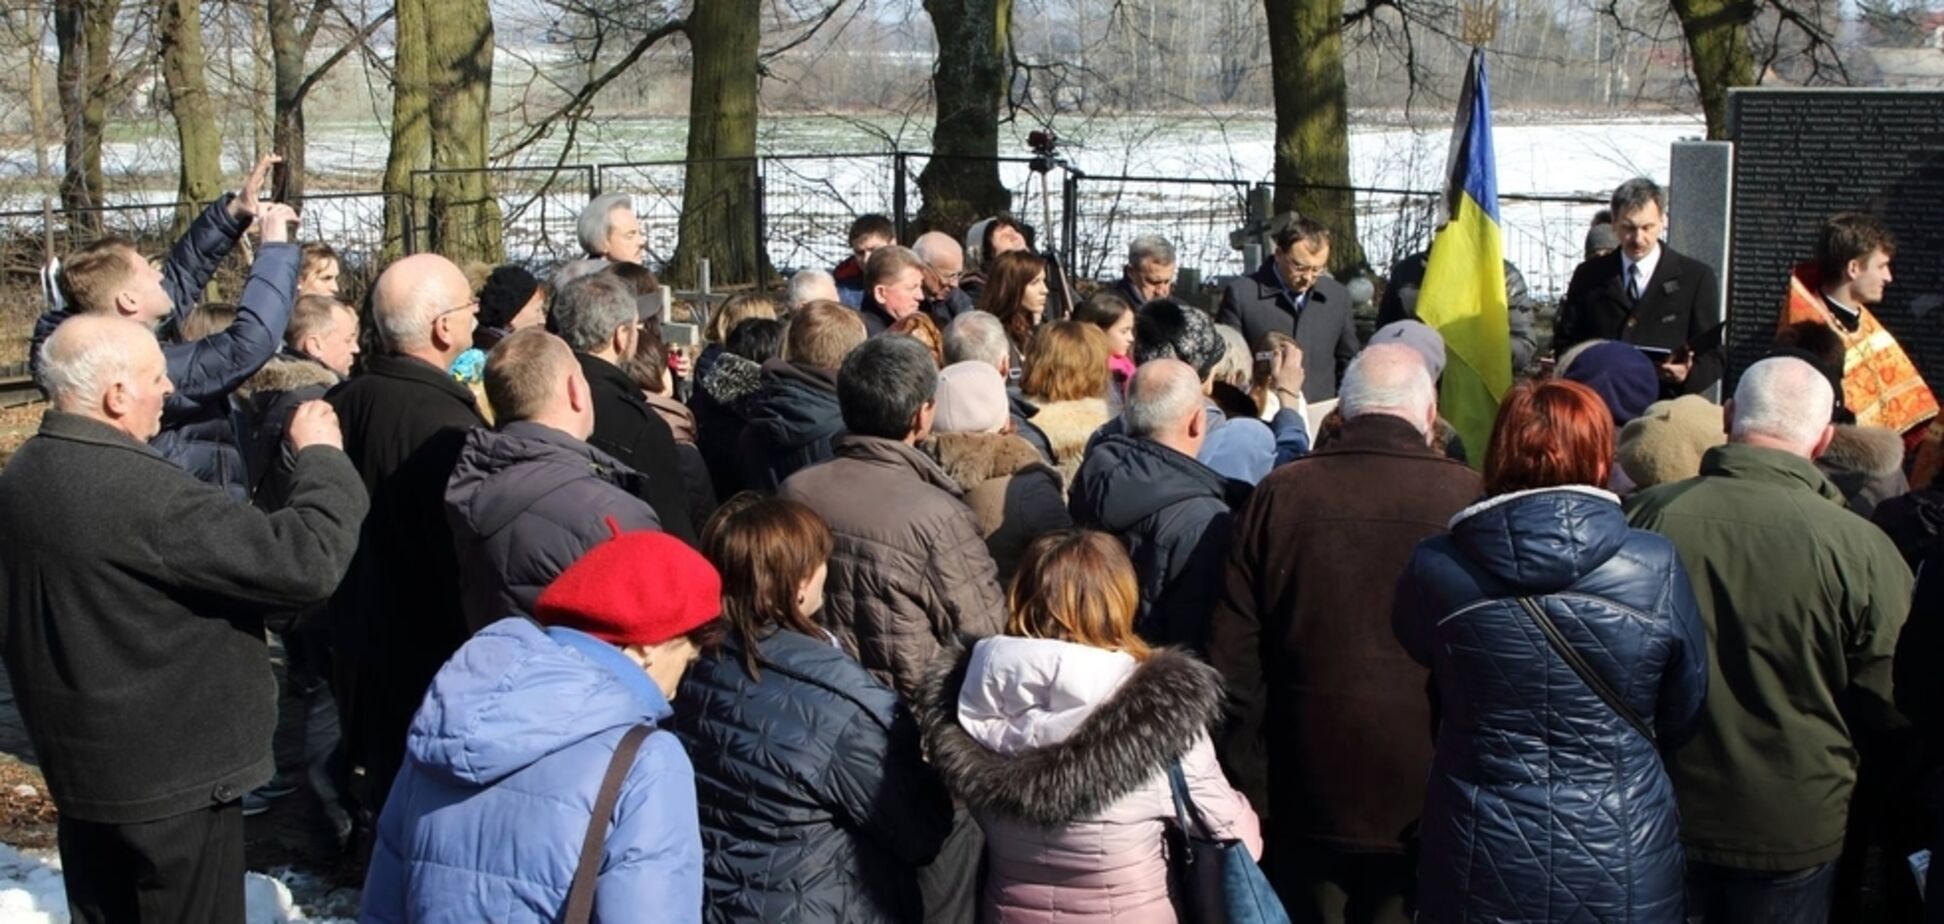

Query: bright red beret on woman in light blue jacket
[533,519,723,646]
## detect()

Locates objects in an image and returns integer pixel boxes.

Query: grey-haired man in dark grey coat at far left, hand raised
[0,315,365,924]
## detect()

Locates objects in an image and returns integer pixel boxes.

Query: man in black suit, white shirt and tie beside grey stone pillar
[1553,177,1722,397]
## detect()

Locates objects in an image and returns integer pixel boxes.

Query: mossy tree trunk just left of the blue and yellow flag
[1252,0,1365,274]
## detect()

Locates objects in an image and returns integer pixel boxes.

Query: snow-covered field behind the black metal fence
[0,117,1703,294]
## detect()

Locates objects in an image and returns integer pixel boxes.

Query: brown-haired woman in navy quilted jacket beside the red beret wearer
[675,494,953,922]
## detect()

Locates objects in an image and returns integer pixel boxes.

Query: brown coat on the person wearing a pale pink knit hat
[920,434,1073,586]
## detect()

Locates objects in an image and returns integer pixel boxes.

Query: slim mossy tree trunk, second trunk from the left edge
[156,0,224,233]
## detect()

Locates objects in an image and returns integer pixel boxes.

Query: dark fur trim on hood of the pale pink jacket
[918,640,1223,827]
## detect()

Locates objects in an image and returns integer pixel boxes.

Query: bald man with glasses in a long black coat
[329,253,486,828]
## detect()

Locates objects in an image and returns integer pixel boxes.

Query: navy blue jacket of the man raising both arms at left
[29,195,301,500]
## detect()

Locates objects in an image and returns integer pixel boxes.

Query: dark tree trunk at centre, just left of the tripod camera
[914,0,1018,237]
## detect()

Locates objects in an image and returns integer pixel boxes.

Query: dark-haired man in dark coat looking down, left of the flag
[1215,218,1363,401]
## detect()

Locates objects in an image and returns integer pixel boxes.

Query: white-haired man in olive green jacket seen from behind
[1627,358,1911,922]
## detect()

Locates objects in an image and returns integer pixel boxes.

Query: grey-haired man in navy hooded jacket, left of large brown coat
[1067,360,1250,652]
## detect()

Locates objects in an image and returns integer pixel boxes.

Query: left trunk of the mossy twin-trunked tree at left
[383,0,432,261]
